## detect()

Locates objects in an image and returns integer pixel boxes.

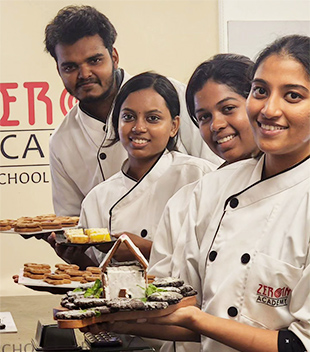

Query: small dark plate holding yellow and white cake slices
[56,228,116,251]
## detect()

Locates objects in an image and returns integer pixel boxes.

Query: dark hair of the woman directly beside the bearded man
[112,72,180,151]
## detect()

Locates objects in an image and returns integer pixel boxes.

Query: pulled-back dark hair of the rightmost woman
[253,34,310,76]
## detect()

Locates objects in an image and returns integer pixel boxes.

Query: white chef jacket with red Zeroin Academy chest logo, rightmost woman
[177,157,310,352]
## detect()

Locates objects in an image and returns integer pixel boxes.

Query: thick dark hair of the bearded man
[44,5,117,61]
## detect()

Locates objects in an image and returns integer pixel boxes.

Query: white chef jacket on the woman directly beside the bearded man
[79,152,214,262]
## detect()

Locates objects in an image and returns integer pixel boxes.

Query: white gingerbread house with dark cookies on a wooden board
[54,235,197,328]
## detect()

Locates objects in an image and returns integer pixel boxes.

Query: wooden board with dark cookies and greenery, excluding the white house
[54,280,197,328]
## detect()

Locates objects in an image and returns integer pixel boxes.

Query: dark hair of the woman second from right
[185,54,254,126]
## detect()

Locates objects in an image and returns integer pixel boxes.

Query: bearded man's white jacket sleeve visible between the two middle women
[169,78,223,166]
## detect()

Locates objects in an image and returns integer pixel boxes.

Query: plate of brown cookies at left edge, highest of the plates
[0,214,79,235]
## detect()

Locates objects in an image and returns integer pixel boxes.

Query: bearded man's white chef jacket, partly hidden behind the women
[50,72,222,216]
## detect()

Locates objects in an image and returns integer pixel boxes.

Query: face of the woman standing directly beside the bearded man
[118,88,179,164]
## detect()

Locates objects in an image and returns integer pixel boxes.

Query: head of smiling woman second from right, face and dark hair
[186,54,259,164]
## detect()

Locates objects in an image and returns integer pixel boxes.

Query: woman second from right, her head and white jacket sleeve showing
[149,54,260,276]
